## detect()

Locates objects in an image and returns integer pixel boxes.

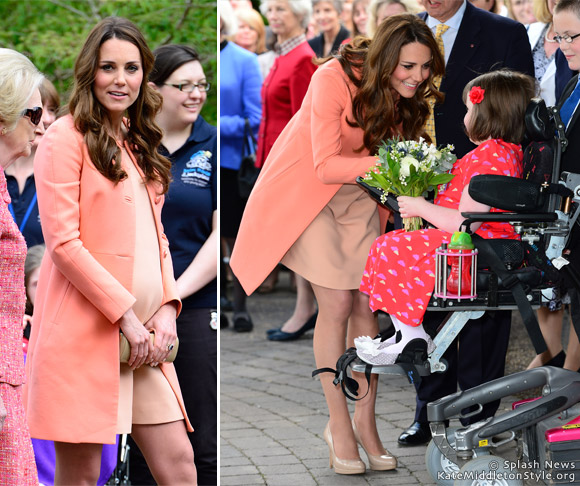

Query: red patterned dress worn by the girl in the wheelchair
[360,139,523,326]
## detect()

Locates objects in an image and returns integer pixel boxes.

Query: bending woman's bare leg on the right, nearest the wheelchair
[347,290,385,455]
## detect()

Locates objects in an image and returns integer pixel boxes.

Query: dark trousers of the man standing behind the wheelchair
[415,311,512,425]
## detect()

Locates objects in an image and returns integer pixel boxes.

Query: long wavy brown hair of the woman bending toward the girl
[323,14,445,153]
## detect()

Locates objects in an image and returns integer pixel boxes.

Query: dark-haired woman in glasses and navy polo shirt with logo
[124,45,218,485]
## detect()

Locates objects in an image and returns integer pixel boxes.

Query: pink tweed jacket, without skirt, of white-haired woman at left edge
[0,168,26,386]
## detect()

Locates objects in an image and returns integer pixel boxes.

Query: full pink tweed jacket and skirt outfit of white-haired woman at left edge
[0,169,38,486]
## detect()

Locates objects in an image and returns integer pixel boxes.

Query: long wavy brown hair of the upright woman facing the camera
[68,17,171,194]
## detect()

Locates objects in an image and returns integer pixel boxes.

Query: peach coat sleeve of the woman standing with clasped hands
[34,118,135,323]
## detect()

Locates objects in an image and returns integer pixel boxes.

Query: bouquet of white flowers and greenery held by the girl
[363,138,457,231]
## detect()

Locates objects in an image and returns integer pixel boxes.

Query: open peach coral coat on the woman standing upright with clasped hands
[25,115,191,444]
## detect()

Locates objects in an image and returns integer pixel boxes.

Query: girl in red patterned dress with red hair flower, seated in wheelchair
[355,70,536,365]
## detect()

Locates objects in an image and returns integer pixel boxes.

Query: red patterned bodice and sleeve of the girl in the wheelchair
[435,139,524,239]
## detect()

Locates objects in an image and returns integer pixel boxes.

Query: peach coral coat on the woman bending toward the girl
[230,60,388,295]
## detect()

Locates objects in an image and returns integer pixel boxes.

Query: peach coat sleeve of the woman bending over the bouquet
[311,68,376,184]
